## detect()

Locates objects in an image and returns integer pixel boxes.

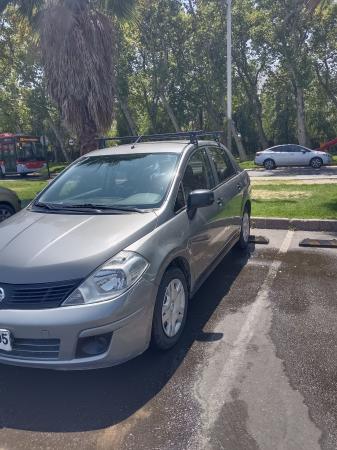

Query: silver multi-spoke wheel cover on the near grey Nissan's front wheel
[162,278,186,338]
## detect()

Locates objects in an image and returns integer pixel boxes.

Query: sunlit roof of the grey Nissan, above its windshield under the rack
[85,140,217,156]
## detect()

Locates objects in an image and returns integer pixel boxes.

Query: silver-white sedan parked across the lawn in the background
[255,144,332,170]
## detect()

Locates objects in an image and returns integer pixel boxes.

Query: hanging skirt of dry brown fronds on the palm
[39,3,114,135]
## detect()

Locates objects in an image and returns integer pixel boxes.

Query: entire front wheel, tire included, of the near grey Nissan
[151,267,189,351]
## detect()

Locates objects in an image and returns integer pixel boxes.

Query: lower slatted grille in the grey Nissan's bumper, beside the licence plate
[0,338,60,360]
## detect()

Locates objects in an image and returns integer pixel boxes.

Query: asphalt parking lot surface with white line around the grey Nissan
[0,230,337,450]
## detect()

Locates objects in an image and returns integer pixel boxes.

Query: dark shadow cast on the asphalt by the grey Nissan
[0,246,254,432]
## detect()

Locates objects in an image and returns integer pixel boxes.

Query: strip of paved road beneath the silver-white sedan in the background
[248,166,337,180]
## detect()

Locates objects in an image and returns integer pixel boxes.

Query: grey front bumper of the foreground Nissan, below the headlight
[0,279,156,370]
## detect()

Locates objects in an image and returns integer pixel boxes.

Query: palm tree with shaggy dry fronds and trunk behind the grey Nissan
[0,0,135,154]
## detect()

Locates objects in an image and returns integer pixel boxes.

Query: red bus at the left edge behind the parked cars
[0,133,47,177]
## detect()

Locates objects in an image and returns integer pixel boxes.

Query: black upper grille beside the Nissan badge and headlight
[0,280,81,309]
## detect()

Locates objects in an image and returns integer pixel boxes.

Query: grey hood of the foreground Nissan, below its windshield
[0,210,157,284]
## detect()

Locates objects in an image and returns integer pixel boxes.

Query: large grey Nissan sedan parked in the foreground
[0,133,251,369]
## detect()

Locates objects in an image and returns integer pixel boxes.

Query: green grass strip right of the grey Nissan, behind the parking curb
[252,181,337,219]
